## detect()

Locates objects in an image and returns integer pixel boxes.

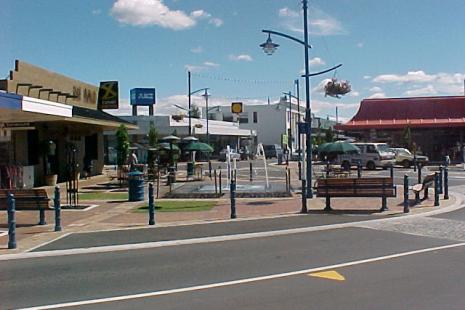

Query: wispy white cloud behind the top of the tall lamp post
[278,7,347,36]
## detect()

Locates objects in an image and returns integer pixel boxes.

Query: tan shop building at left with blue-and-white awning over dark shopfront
[0,60,137,188]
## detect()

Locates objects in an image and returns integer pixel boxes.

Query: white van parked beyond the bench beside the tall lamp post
[338,142,396,170]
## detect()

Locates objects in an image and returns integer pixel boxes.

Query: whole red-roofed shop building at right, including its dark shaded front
[337,96,465,161]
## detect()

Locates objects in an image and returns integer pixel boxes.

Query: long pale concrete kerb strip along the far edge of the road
[0,193,464,261]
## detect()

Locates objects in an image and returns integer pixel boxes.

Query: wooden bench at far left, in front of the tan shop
[0,189,50,225]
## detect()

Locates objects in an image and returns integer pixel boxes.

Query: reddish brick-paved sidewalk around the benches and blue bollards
[0,167,455,255]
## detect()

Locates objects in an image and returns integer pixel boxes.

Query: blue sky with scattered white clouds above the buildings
[0,0,465,119]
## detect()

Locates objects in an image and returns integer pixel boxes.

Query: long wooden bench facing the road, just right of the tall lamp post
[315,177,397,211]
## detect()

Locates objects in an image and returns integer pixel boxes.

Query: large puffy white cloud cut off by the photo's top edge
[110,0,222,30]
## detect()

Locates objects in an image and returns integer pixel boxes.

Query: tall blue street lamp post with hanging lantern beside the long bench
[260,0,342,198]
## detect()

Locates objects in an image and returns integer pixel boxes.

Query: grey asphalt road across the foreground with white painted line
[0,200,465,309]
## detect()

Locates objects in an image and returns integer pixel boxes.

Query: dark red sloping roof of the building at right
[336,96,465,130]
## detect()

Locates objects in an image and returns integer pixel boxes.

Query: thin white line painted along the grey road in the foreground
[20,242,465,310]
